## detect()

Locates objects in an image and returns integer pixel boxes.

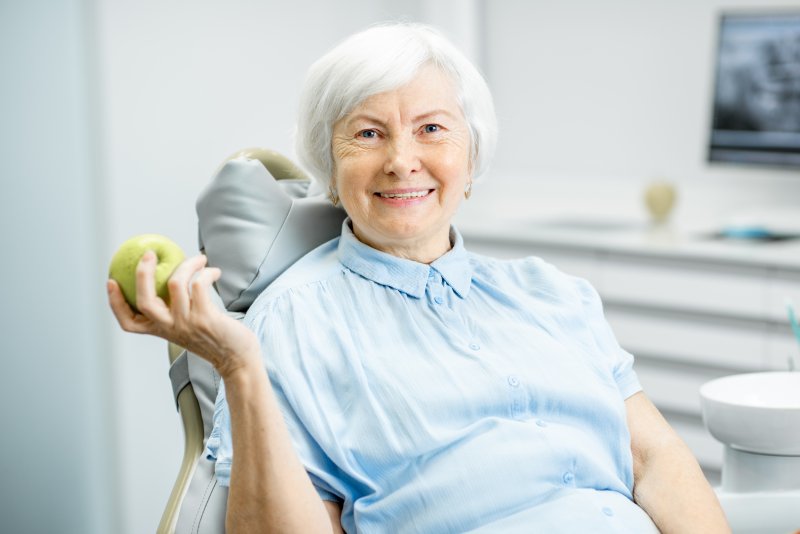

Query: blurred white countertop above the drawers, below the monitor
[455,180,800,271]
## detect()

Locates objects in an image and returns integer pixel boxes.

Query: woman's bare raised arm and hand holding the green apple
[108,253,341,533]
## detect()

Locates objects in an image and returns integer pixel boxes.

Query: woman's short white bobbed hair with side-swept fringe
[295,23,497,188]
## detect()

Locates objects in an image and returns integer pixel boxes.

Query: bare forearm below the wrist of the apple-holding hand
[224,360,332,532]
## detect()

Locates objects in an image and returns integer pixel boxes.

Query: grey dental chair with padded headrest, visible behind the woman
[158,148,345,534]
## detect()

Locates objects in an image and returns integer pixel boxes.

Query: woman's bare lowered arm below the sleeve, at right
[625,392,731,534]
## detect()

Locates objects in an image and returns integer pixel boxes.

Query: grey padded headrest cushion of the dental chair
[196,151,346,312]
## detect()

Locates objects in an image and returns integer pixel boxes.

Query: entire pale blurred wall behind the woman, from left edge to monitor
[0,0,800,534]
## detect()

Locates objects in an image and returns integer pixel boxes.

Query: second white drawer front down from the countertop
[606,306,767,372]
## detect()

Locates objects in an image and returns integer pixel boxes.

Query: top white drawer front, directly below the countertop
[598,256,768,318]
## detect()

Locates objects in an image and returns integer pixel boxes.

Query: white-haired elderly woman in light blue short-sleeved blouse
[109,24,728,534]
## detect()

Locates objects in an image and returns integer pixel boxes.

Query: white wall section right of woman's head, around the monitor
[485,0,800,226]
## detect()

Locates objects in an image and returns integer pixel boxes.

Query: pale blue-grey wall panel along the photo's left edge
[0,0,118,534]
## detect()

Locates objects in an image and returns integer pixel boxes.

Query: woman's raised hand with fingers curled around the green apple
[107,252,261,378]
